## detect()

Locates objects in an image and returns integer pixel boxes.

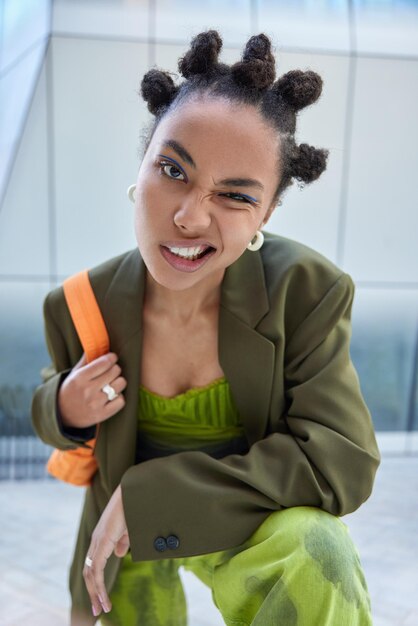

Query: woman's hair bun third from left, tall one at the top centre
[231,33,276,89]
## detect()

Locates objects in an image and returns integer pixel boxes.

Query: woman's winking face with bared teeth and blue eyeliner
[135,99,279,290]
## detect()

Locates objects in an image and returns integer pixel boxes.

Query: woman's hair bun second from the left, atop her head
[178,30,222,78]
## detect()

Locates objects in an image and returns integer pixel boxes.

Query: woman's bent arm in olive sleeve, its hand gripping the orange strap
[32,290,126,450]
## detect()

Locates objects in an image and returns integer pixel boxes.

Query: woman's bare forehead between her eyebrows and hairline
[151,98,279,183]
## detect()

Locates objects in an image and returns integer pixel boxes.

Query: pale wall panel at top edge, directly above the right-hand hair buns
[258,0,349,52]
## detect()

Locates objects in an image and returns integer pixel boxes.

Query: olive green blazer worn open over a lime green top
[32,234,379,609]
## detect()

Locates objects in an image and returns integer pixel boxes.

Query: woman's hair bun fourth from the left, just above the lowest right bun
[273,70,322,111]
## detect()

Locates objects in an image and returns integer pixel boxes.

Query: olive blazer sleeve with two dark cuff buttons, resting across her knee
[121,274,379,560]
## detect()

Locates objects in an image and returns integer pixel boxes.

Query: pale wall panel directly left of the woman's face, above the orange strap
[53,38,147,274]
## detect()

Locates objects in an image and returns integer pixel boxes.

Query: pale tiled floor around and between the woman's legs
[0,456,418,626]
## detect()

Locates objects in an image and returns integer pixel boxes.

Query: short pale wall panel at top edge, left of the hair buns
[52,0,149,37]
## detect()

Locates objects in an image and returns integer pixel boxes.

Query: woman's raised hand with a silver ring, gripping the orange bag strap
[58,352,126,428]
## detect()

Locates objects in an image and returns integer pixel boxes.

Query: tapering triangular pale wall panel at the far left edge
[0,64,50,278]
